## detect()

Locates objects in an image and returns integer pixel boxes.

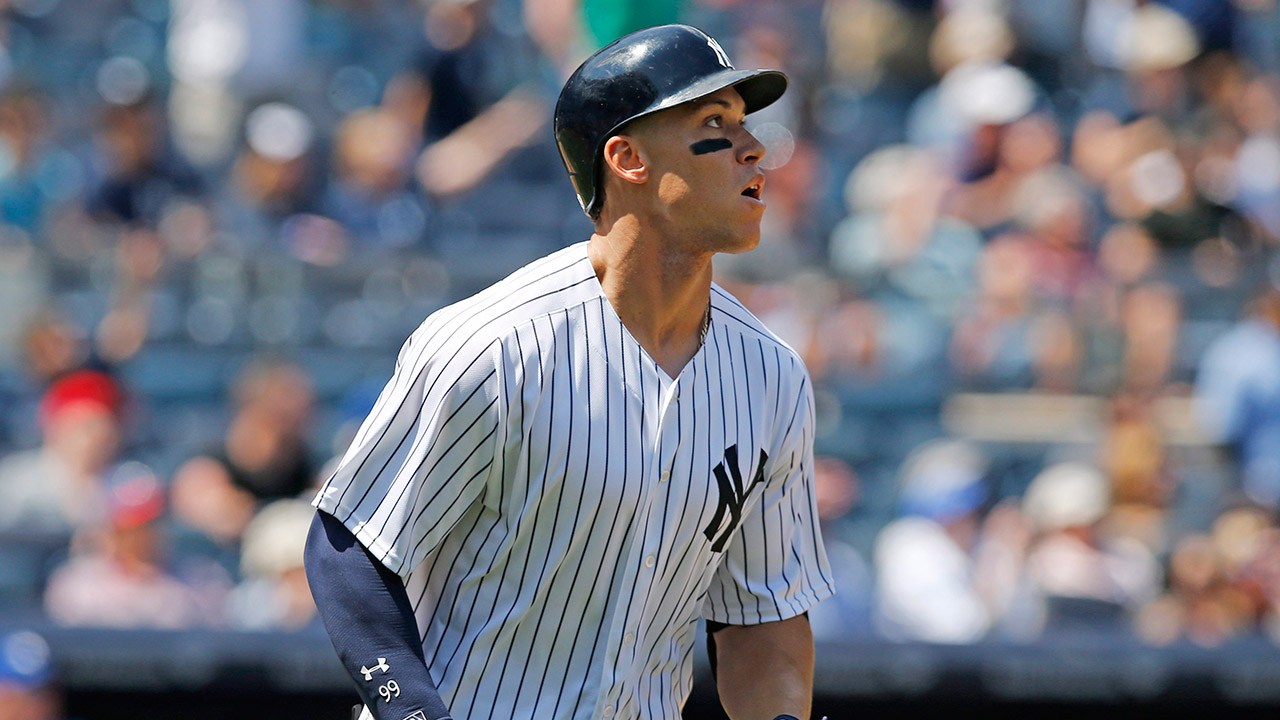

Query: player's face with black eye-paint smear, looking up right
[634,87,764,252]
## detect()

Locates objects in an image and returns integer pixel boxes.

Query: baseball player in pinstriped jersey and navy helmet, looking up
[306,26,833,720]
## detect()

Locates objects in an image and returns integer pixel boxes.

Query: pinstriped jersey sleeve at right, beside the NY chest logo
[703,377,835,625]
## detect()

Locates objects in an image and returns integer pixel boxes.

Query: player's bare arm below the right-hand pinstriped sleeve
[709,615,813,720]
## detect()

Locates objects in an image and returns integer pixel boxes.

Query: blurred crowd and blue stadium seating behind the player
[0,0,1280,720]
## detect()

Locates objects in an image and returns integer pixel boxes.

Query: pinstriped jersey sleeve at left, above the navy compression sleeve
[312,326,504,578]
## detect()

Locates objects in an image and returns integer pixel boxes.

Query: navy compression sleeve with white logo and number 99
[305,511,449,720]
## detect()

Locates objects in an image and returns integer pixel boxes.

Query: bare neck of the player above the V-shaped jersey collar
[588,222,712,378]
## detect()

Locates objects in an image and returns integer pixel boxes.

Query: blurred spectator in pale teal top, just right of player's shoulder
[810,140,980,402]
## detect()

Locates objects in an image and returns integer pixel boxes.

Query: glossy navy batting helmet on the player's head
[556,24,787,215]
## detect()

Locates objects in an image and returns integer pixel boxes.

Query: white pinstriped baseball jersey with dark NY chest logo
[315,242,833,719]
